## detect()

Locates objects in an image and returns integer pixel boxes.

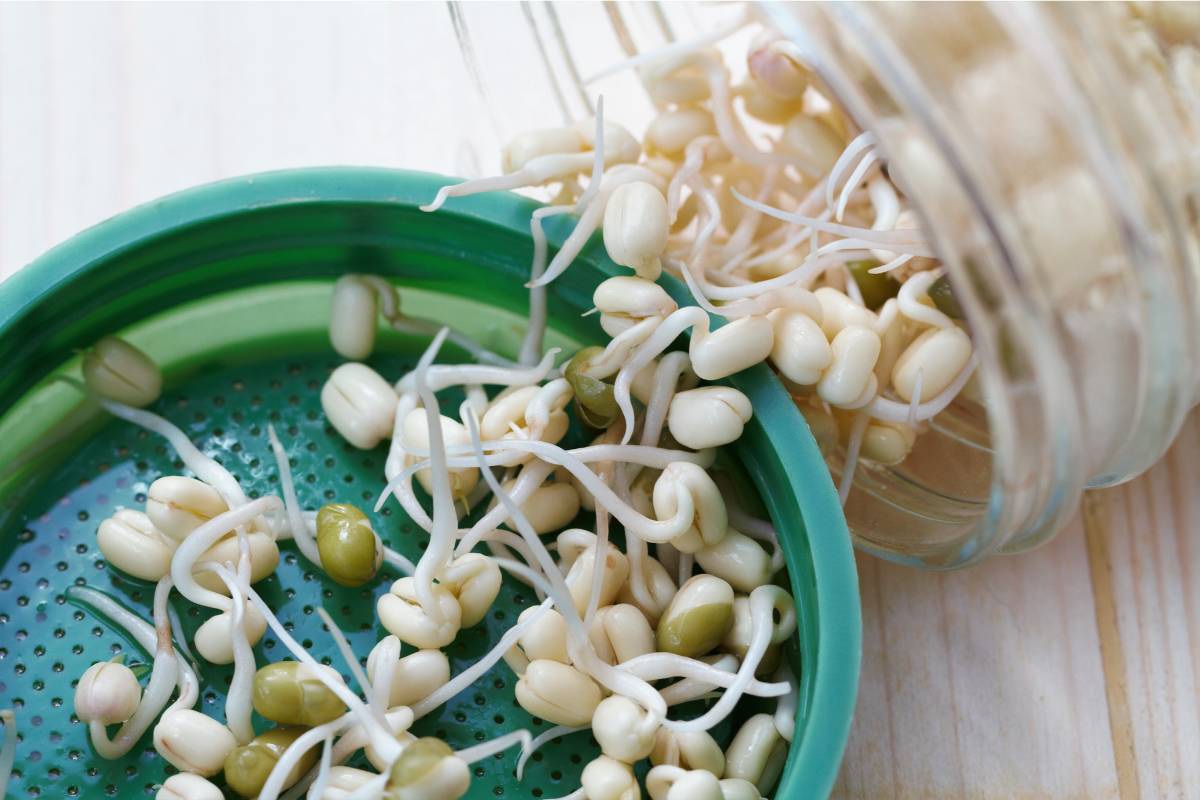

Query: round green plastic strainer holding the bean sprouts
[0,168,860,798]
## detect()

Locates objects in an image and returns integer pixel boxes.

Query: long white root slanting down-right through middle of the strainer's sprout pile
[467,414,667,720]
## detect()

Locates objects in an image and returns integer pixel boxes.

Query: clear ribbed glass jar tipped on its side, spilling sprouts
[762,2,1200,569]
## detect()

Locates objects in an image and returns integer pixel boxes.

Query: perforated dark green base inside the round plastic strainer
[0,357,777,798]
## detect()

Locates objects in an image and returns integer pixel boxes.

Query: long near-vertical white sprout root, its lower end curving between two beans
[413,329,458,621]
